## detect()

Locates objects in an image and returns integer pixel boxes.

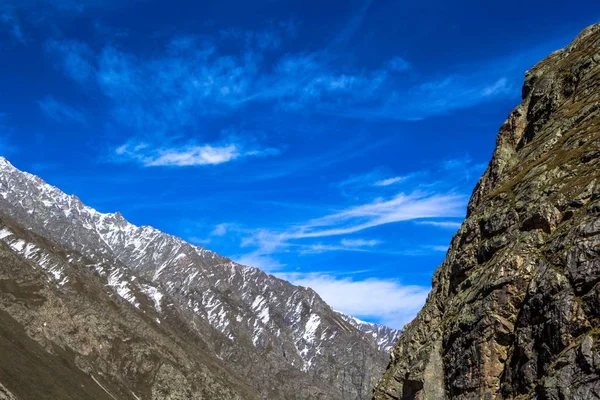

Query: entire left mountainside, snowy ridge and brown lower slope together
[0,155,399,400]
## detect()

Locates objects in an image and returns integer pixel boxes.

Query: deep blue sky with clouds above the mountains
[0,0,600,327]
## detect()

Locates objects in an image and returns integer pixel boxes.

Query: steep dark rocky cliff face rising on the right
[374,25,600,400]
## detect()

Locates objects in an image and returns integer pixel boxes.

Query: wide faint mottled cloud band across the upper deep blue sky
[46,19,512,138]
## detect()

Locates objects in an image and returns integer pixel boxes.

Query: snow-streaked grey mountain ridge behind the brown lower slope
[0,158,399,399]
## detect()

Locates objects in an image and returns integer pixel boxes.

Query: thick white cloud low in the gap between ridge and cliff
[275,273,429,328]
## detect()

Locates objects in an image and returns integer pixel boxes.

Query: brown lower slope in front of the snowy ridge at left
[0,217,260,400]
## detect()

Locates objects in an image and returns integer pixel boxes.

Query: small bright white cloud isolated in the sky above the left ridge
[115,143,278,167]
